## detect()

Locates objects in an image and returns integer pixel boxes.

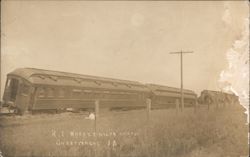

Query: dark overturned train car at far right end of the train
[198,90,239,105]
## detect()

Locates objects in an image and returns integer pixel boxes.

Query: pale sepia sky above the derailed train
[1,1,249,98]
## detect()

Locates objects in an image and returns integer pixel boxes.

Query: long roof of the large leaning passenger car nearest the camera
[8,68,148,91]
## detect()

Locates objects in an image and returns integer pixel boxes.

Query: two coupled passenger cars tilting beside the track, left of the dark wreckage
[1,68,197,114]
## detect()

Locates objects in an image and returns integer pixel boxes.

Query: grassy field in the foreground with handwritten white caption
[0,105,248,157]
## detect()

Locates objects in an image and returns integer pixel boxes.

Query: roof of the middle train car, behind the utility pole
[146,84,196,95]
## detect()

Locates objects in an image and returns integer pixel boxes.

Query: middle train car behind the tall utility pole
[147,84,197,108]
